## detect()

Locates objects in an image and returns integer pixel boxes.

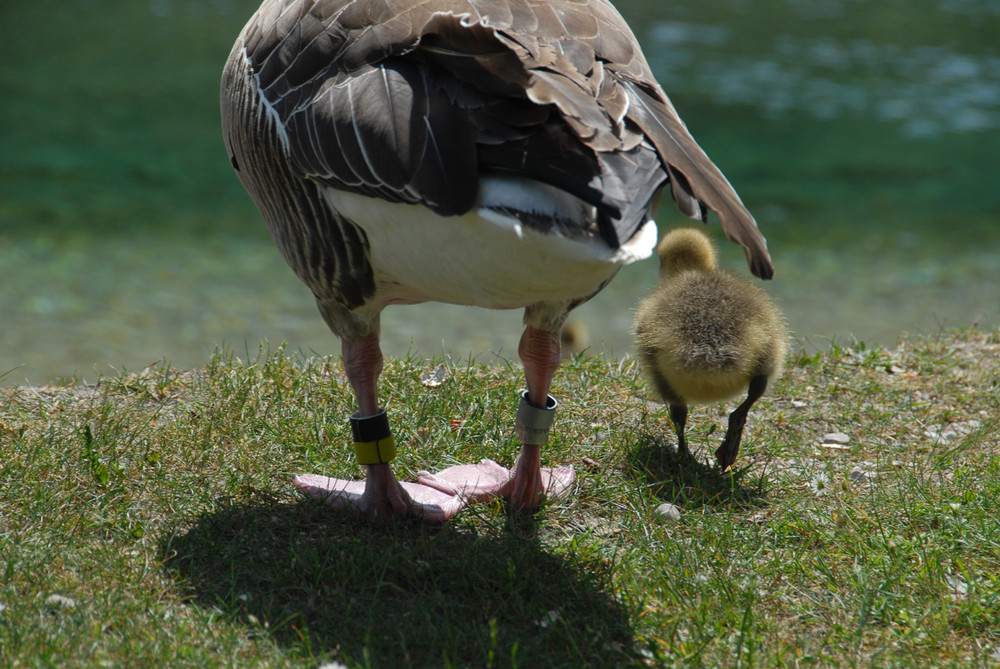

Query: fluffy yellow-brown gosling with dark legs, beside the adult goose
[633,228,788,470]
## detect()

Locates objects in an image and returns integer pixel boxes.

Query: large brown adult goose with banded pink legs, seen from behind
[221,0,772,520]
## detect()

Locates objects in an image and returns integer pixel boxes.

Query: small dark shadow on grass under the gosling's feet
[625,433,767,509]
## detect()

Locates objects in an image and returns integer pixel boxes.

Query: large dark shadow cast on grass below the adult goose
[162,488,636,667]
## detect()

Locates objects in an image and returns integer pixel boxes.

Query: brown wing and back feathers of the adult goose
[234,0,773,278]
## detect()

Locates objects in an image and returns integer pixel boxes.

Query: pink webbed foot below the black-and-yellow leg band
[293,474,468,522]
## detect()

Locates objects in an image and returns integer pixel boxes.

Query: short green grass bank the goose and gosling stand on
[0,330,1000,667]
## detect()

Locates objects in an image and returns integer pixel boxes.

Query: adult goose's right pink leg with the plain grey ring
[504,325,573,511]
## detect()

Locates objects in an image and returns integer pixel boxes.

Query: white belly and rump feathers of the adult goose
[324,178,657,309]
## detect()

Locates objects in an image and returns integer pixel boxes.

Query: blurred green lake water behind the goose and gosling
[0,0,1000,385]
